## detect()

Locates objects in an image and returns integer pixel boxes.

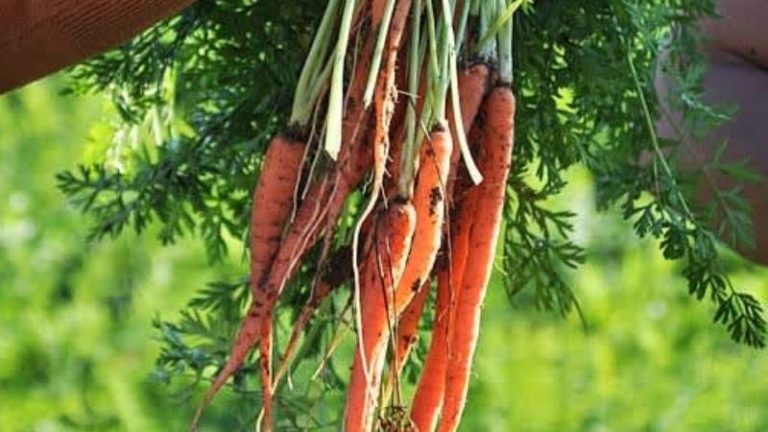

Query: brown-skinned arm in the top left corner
[0,0,194,93]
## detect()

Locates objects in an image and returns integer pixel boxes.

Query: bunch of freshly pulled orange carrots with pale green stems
[191,0,523,432]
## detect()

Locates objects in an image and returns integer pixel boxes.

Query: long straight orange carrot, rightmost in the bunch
[439,86,515,432]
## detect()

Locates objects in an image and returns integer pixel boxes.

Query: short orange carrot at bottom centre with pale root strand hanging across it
[344,201,416,432]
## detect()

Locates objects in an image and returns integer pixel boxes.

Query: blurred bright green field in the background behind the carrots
[0,77,768,432]
